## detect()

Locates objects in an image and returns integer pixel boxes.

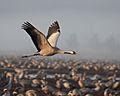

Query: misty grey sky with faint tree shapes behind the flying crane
[0,0,120,58]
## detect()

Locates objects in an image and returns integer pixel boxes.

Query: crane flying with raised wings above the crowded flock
[22,21,76,57]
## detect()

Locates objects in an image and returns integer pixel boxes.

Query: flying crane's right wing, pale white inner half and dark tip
[47,21,60,47]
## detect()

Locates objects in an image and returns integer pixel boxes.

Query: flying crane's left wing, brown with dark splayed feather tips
[22,22,51,52]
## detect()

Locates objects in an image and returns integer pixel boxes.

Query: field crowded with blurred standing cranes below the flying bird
[0,57,120,96]
